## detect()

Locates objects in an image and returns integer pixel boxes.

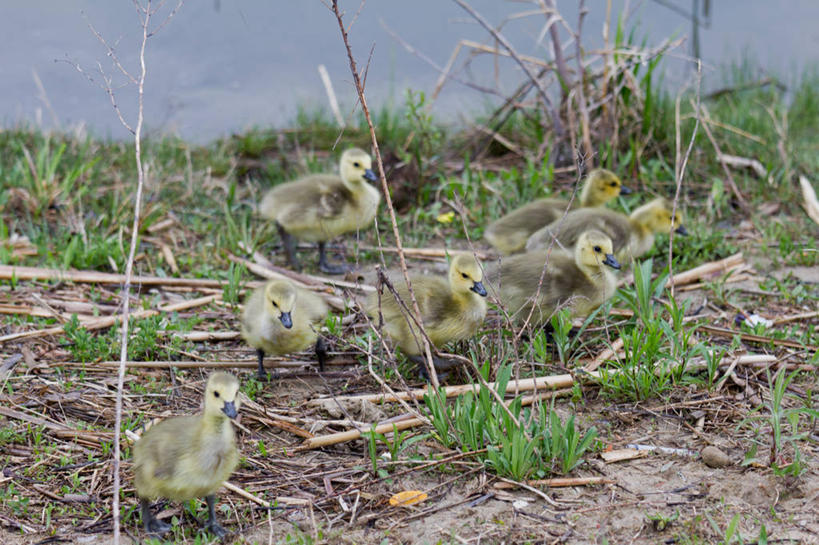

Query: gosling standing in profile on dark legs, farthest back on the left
[259,148,381,274]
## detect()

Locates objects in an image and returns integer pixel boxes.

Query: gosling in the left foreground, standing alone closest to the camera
[134,372,240,538]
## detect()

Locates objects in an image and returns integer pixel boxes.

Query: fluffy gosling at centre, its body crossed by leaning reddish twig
[365,254,486,379]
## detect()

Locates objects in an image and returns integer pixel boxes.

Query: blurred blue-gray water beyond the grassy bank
[0,0,819,142]
